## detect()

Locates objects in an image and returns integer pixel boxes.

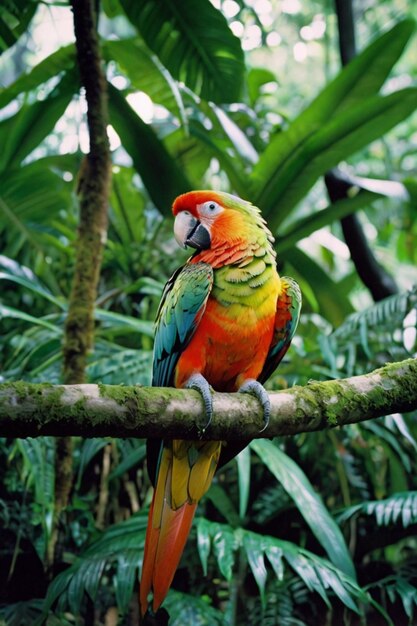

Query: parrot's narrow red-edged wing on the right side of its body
[258,276,301,383]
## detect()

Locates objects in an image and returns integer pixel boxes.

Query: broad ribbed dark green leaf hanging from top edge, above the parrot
[120,0,244,103]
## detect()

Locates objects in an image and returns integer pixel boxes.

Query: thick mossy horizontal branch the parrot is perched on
[0,359,417,441]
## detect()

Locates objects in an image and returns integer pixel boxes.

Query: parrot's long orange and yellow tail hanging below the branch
[139,440,221,616]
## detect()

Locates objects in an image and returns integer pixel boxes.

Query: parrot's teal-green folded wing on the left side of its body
[152,263,213,387]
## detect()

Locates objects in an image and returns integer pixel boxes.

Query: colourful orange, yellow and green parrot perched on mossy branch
[140,191,301,616]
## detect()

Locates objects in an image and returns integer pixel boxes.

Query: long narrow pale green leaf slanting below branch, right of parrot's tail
[250,439,355,578]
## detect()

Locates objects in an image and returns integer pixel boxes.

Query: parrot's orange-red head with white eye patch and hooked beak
[172,190,273,251]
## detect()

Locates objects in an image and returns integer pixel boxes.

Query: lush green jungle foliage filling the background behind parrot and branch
[0,0,417,626]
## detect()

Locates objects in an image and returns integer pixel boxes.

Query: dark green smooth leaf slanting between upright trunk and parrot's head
[108,84,191,215]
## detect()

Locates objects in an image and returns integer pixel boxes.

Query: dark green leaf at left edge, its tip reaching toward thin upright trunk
[0,73,78,172]
